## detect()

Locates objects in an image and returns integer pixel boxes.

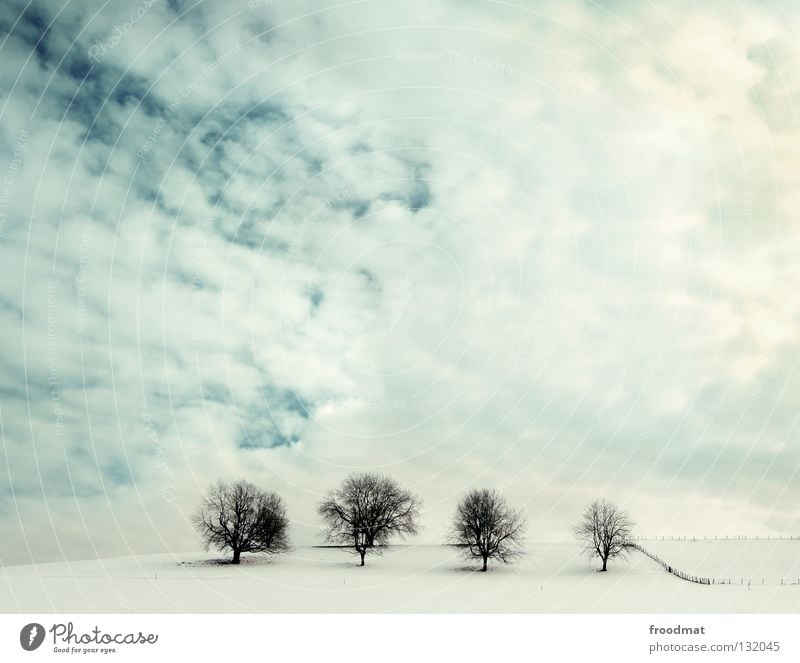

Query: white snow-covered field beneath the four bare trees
[0,541,800,613]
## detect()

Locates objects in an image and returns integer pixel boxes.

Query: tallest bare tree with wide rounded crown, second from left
[317,473,421,566]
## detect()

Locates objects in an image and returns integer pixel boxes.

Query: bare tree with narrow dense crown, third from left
[450,489,525,571]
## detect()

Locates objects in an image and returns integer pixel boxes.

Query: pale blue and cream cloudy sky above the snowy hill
[0,0,800,565]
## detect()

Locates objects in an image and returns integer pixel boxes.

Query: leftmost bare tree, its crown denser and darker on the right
[193,481,289,564]
